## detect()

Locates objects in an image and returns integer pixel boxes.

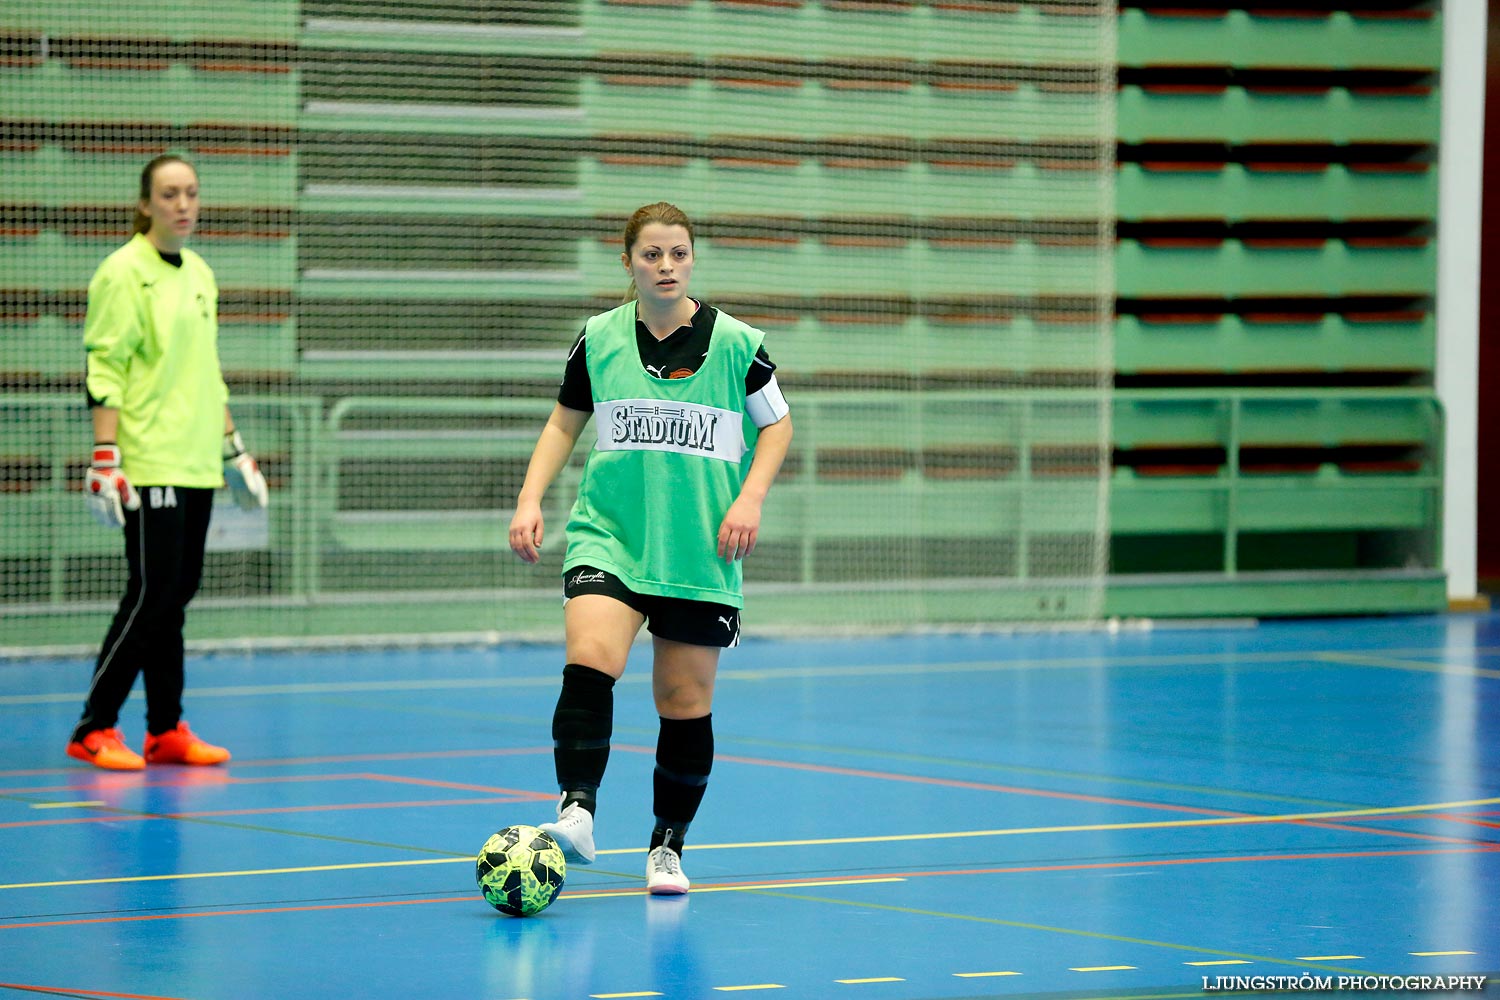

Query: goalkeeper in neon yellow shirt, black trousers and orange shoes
[68,156,267,771]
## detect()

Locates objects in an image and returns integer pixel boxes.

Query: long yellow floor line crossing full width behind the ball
[0,798,1500,891]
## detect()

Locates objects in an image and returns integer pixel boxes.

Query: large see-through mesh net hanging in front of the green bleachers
[0,0,1115,645]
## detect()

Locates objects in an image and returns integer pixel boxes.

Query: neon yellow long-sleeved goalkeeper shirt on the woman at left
[84,234,230,487]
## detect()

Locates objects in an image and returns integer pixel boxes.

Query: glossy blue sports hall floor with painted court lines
[0,615,1500,1000]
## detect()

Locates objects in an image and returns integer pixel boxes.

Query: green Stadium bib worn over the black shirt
[563,301,764,607]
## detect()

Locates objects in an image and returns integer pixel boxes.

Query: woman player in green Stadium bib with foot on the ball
[510,202,792,895]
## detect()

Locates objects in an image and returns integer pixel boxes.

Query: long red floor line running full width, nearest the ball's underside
[0,846,1500,941]
